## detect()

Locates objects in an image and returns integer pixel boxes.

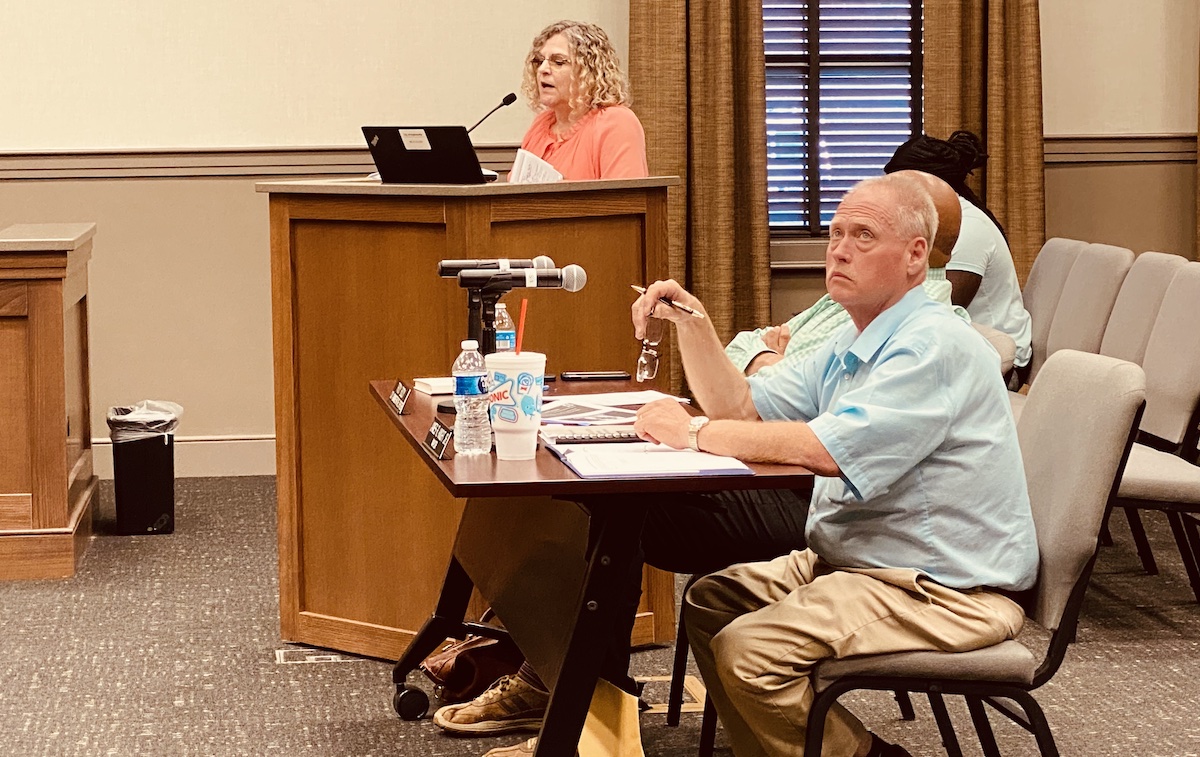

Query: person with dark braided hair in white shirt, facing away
[883,131,1033,387]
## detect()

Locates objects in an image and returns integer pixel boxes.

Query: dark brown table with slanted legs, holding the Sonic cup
[371,381,812,757]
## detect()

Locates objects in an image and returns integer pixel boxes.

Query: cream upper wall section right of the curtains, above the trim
[1040,0,1200,136]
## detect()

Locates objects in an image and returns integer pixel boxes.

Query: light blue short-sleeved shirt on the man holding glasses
[749,287,1038,590]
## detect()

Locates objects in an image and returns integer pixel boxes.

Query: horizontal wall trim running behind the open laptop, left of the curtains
[0,144,517,181]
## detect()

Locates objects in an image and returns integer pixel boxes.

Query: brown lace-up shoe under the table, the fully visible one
[433,675,550,734]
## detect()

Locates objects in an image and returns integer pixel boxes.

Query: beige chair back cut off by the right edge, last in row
[1141,263,1200,444]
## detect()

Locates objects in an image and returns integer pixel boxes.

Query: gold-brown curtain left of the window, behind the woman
[629,0,770,386]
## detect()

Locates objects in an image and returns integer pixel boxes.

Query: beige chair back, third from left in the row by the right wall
[1100,252,1188,365]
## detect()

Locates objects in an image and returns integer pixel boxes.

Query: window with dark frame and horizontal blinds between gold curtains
[762,0,922,236]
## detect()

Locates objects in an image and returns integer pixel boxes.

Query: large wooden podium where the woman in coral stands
[258,178,678,660]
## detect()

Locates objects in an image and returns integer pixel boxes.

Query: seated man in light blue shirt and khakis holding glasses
[634,176,1038,757]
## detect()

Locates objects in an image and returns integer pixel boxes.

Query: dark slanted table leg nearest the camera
[535,499,647,757]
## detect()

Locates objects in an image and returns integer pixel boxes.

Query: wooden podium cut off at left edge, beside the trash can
[0,223,96,579]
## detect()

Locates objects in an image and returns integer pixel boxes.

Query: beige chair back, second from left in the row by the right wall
[1046,245,1133,369]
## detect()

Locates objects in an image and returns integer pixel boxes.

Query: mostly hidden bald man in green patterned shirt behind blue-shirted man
[725,170,971,376]
